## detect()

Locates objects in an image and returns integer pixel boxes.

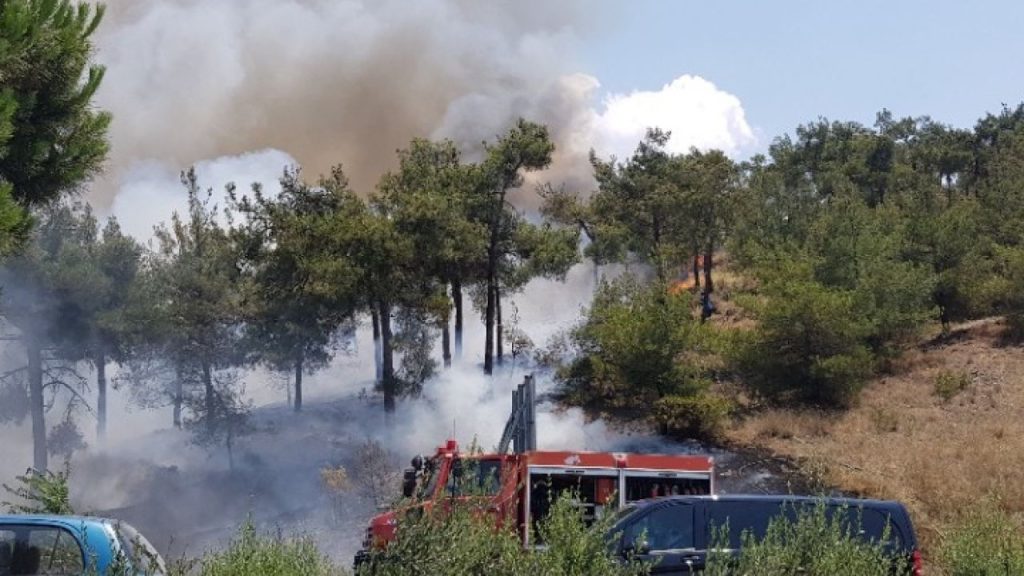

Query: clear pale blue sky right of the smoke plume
[583,0,1024,146]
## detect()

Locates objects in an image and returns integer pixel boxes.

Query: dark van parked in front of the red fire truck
[610,494,922,576]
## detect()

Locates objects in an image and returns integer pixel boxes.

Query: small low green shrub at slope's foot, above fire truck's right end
[654,394,735,440]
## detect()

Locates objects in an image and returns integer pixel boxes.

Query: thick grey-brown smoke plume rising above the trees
[95,0,587,199]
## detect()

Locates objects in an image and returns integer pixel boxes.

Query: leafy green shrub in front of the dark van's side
[705,498,902,576]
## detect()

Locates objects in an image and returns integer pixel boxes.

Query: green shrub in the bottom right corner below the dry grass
[940,502,1024,576]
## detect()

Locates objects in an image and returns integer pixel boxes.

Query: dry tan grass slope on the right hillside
[728,321,1024,551]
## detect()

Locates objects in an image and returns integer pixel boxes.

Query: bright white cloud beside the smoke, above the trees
[593,75,757,159]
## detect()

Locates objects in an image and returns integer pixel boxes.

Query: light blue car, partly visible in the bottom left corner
[0,515,167,576]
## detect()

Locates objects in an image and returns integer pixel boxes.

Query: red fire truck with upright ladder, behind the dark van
[355,377,715,565]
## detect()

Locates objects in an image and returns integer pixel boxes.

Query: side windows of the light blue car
[0,526,85,576]
